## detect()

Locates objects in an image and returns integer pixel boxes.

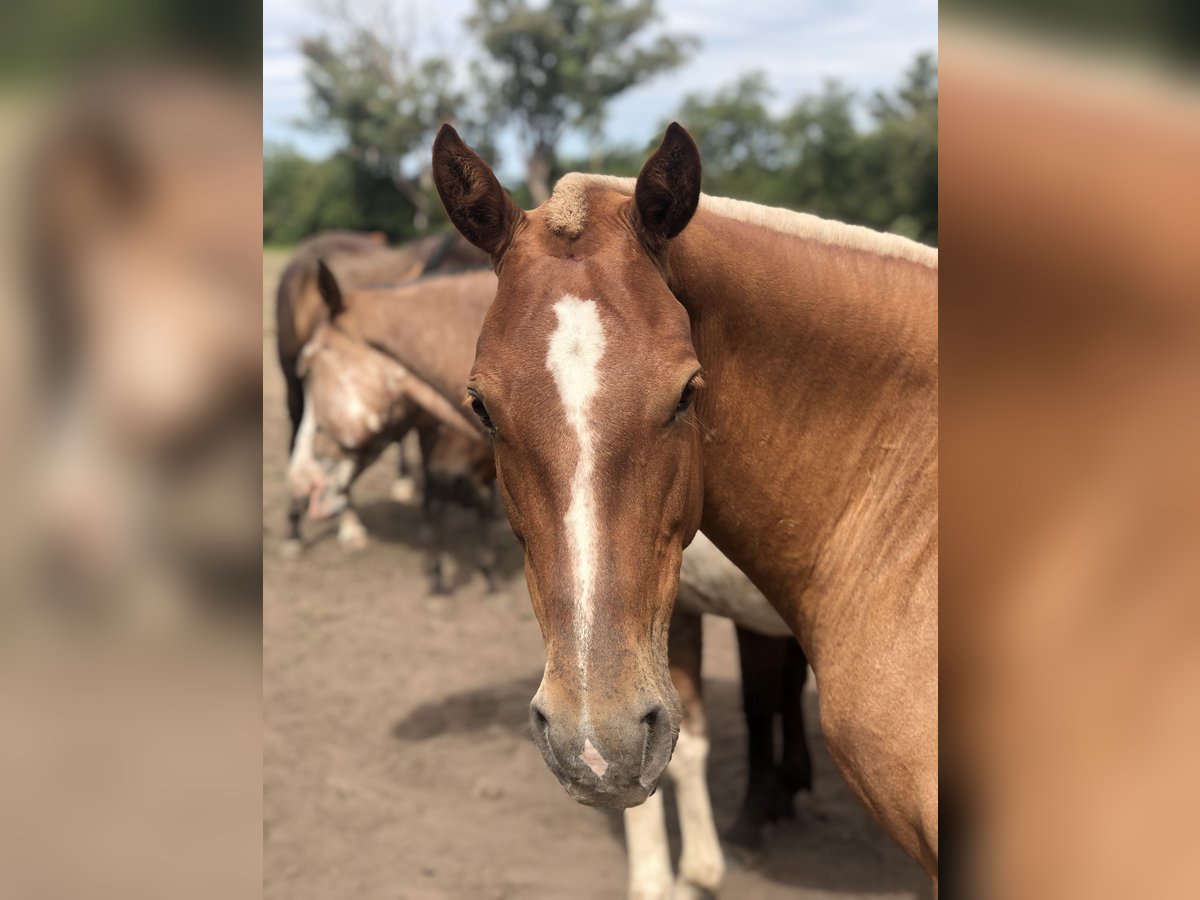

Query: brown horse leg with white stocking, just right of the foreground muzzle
[667,608,725,900]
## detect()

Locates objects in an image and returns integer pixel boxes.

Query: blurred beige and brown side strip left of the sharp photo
[0,0,263,899]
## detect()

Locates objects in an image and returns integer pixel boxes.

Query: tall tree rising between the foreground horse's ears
[467,0,692,204]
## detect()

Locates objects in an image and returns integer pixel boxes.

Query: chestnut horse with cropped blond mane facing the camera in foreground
[433,124,937,880]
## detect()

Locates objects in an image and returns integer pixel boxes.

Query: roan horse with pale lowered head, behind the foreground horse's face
[288,262,497,594]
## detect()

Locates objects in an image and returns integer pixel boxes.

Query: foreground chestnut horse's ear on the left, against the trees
[433,124,524,262]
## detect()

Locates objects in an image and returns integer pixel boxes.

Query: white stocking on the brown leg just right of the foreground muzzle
[667,728,725,896]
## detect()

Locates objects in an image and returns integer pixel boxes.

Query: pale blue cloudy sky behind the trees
[263,0,937,178]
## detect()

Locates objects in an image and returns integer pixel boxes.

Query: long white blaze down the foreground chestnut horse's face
[546,294,604,689]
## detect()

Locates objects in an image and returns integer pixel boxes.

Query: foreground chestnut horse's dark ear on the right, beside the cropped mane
[634,122,700,247]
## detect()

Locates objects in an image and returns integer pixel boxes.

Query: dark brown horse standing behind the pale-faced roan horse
[275,232,487,556]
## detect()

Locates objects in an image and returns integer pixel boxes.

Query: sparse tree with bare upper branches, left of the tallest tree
[301,2,486,236]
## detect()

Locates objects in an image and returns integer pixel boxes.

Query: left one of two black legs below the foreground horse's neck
[726,626,794,864]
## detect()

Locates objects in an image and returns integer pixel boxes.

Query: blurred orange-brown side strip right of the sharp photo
[940,12,1200,900]
